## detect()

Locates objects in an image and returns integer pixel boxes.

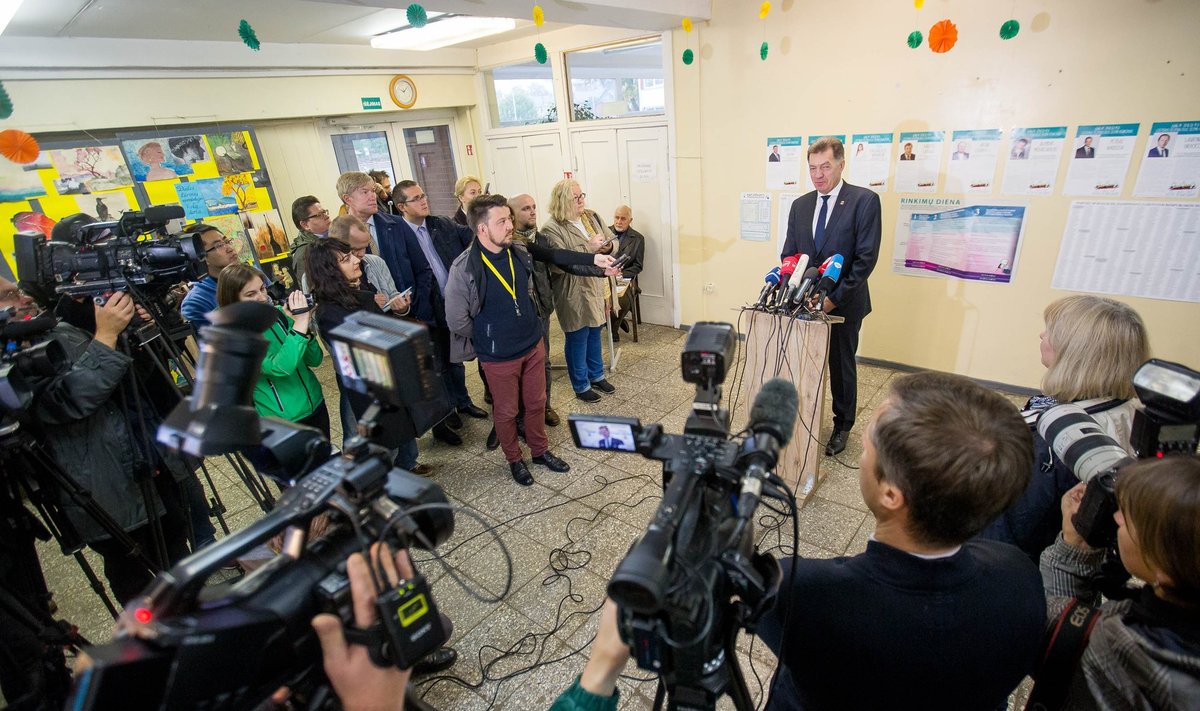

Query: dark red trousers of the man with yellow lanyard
[482,341,550,464]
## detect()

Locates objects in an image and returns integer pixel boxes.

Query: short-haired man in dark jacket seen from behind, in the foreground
[757,372,1045,711]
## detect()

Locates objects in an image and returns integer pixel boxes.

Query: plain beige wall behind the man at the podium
[674,0,1200,387]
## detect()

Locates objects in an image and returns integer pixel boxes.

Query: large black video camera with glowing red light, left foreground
[71,301,454,709]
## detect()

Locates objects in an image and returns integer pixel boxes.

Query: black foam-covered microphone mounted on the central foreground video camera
[738,377,800,520]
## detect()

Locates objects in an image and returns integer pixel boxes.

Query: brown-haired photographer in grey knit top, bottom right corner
[1039,455,1200,709]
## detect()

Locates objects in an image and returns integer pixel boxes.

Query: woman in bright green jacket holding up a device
[217,263,329,440]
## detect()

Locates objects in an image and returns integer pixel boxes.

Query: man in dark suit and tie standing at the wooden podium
[780,137,882,455]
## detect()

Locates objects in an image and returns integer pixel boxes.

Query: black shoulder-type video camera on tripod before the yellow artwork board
[13,205,205,303]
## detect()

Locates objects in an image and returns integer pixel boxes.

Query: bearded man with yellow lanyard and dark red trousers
[445,195,612,486]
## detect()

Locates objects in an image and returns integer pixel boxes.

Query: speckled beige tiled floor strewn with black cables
[32,325,1032,710]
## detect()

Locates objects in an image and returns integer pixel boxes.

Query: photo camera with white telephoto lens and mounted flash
[1038,358,1200,548]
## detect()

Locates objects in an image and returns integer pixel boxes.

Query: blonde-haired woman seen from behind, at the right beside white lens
[983,295,1150,560]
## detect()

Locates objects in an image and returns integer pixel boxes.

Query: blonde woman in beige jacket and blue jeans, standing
[541,179,617,402]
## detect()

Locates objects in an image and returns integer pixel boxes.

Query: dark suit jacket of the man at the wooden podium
[780,181,883,321]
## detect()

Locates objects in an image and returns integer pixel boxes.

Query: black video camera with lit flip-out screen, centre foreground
[569,322,798,709]
